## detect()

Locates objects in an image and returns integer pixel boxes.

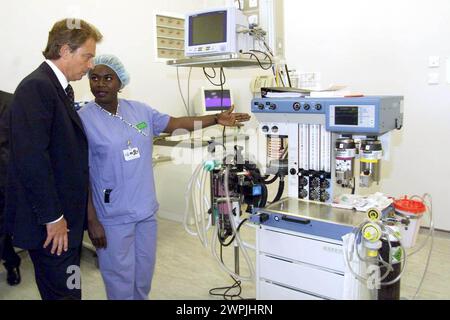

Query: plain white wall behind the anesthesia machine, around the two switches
[285,0,450,230]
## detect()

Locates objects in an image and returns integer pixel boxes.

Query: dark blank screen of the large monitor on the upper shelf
[189,10,227,46]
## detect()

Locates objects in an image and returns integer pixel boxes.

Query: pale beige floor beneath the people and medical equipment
[0,219,450,300]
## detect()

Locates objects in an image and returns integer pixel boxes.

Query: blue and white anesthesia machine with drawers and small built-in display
[251,96,432,299]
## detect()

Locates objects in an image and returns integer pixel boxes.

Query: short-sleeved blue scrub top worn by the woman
[78,99,170,225]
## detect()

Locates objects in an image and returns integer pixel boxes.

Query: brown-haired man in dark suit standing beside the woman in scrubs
[5,19,102,299]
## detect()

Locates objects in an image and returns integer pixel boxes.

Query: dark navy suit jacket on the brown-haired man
[5,62,89,249]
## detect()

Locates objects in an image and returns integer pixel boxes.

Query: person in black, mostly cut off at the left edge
[0,90,21,286]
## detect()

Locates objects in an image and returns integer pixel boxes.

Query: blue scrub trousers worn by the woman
[97,214,157,300]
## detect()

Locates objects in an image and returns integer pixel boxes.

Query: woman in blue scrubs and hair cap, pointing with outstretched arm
[79,55,250,300]
